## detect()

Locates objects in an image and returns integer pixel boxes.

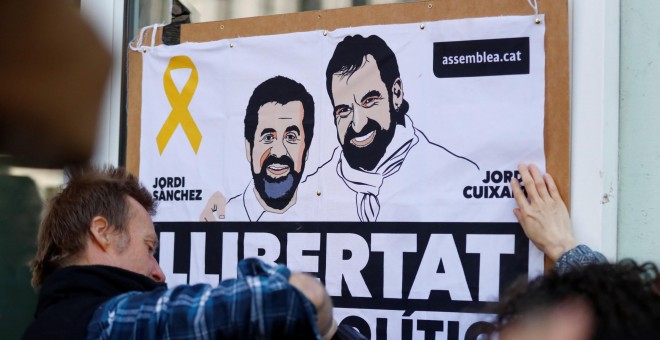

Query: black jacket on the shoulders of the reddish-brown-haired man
[23,266,165,340]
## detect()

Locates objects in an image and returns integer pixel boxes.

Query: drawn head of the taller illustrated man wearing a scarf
[325,35,408,171]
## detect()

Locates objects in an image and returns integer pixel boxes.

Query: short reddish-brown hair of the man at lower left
[30,166,156,288]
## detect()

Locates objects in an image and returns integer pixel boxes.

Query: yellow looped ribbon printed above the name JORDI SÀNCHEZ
[156,56,202,155]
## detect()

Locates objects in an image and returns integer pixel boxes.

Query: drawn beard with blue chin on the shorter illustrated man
[252,155,301,210]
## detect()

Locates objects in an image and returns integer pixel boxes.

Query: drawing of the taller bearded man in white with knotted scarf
[319,35,479,222]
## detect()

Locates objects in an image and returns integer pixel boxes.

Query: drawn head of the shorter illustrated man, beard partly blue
[244,76,314,212]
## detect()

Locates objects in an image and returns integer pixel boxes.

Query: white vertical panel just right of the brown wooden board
[568,0,619,259]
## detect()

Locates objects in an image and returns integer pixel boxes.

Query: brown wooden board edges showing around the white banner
[126,0,570,206]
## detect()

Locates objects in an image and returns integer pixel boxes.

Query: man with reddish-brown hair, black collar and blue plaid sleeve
[23,167,336,339]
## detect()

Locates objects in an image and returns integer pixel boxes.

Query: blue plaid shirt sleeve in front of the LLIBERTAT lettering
[87,259,321,339]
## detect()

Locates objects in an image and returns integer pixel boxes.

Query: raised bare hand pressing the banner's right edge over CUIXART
[511,164,577,262]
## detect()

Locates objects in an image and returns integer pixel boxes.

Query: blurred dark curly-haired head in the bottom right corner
[496,261,660,340]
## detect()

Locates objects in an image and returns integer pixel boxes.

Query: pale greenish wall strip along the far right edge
[618,0,660,263]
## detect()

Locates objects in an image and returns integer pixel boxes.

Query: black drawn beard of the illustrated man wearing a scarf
[342,118,396,171]
